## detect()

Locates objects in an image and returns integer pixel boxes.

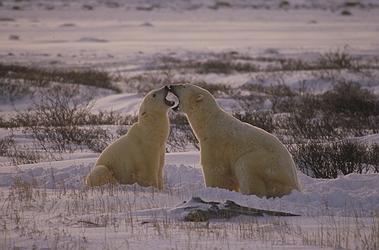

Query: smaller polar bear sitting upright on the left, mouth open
[86,87,175,189]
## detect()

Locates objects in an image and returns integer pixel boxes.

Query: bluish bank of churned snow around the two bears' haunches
[0,162,379,217]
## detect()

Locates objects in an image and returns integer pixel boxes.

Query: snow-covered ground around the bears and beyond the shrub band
[0,0,379,249]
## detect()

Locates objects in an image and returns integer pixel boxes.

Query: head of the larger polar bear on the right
[168,84,217,114]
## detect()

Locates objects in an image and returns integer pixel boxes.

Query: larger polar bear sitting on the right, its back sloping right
[169,84,301,198]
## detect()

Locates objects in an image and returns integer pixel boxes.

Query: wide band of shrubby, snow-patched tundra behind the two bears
[0,49,379,178]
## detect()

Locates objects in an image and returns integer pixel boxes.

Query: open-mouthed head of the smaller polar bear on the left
[139,87,175,118]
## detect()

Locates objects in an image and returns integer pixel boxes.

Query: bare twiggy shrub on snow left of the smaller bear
[11,85,116,153]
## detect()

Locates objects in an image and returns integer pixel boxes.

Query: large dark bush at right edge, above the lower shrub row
[284,81,379,139]
